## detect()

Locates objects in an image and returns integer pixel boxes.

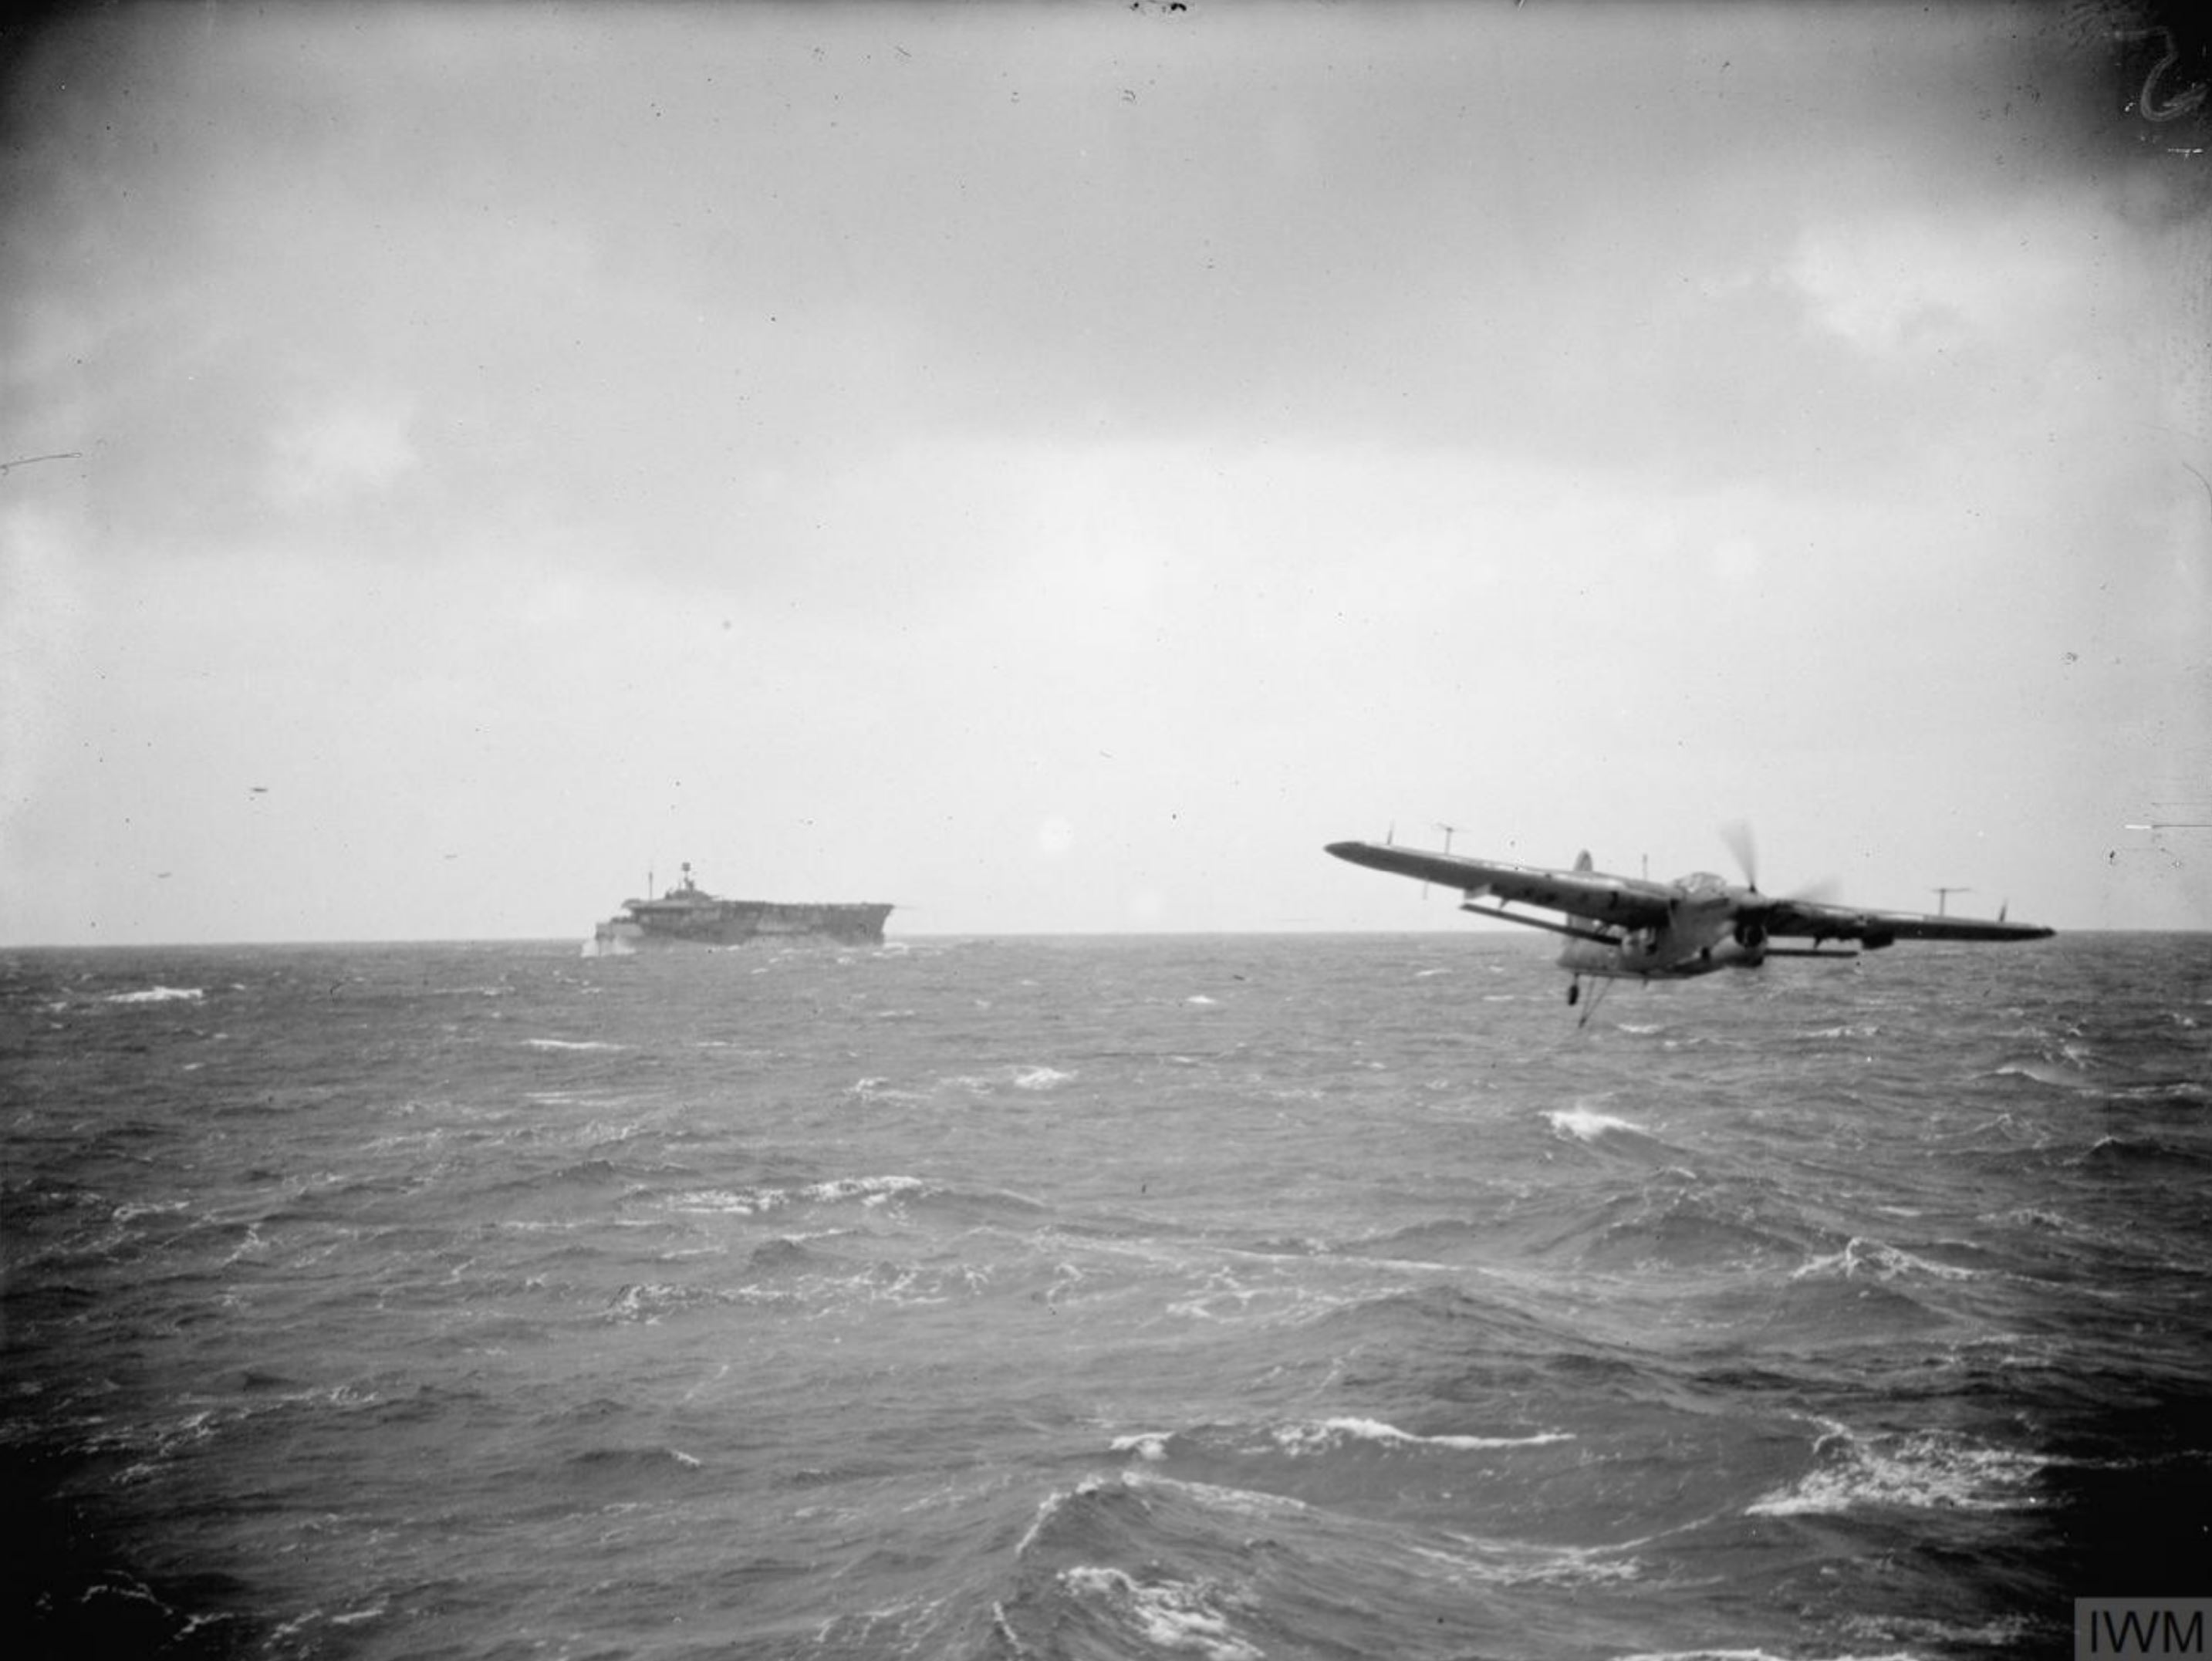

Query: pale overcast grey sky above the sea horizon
[0,0,2212,944]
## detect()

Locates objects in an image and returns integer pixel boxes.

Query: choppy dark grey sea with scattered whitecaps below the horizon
[0,931,2212,1661]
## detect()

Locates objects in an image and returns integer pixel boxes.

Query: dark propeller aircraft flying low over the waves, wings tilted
[1325,832,2055,1020]
